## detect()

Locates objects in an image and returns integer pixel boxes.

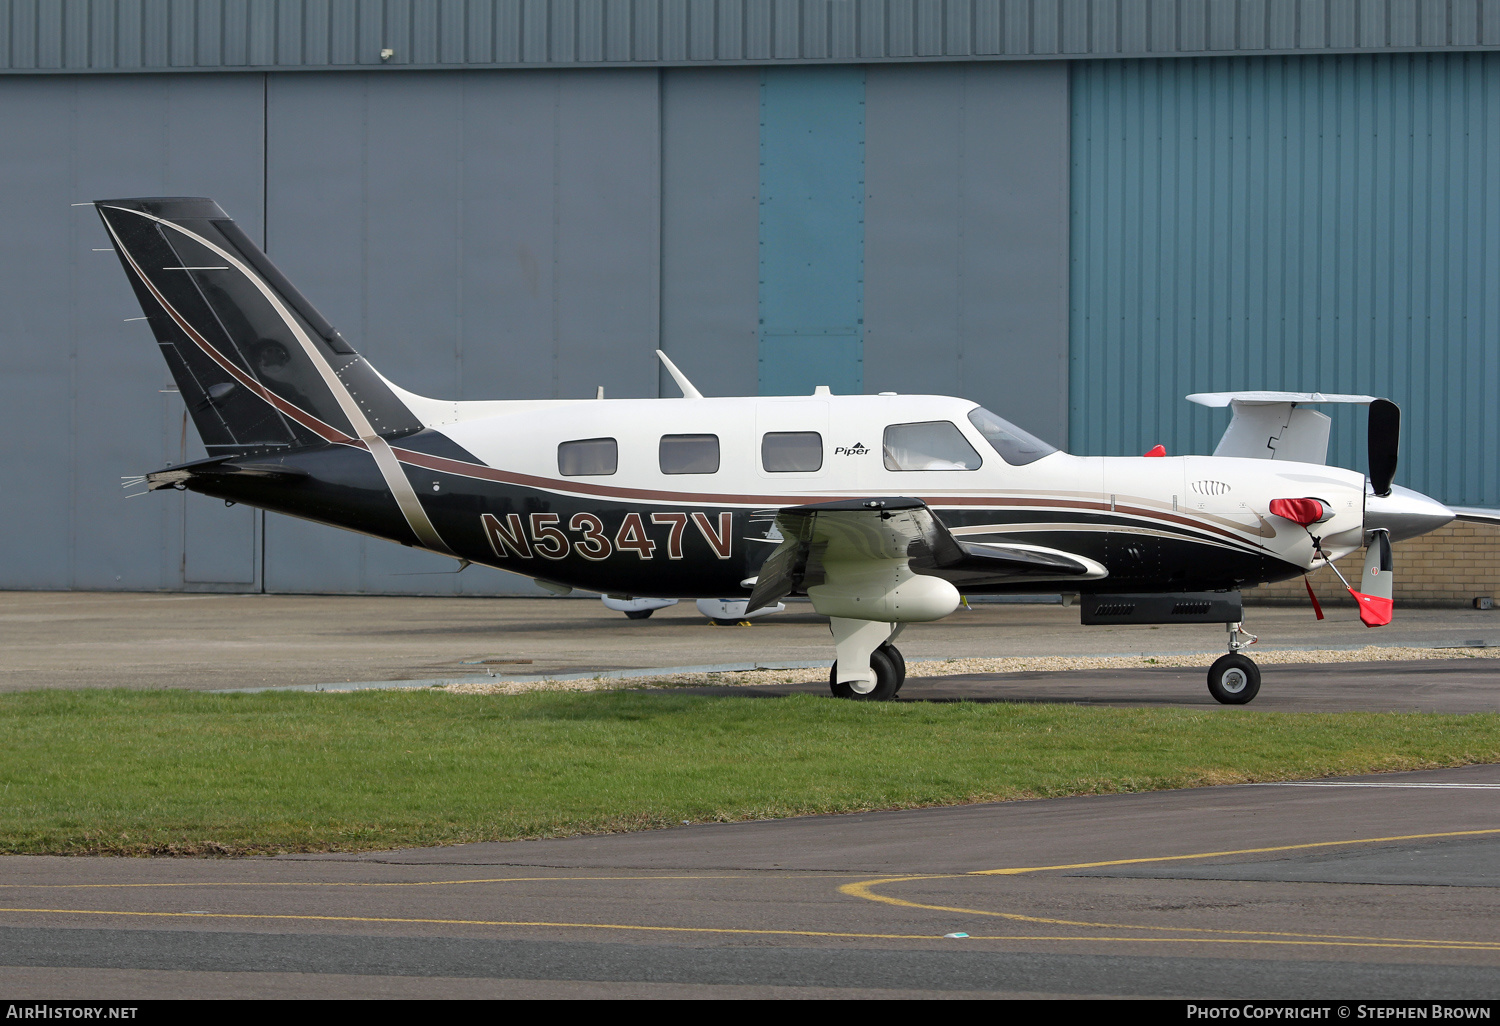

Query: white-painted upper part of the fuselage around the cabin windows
[414,393,1365,569]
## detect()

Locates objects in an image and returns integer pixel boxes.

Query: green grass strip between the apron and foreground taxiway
[0,690,1500,855]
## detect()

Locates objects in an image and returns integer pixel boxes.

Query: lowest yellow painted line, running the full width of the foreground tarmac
[0,908,1500,951]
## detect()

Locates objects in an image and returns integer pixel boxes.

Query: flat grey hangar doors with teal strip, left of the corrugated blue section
[0,63,1070,594]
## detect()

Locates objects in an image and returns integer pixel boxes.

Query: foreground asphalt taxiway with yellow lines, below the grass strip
[0,767,1500,999]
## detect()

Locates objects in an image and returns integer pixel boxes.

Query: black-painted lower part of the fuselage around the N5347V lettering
[149,432,1301,599]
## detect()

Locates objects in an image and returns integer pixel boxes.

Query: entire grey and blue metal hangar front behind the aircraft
[0,0,1500,594]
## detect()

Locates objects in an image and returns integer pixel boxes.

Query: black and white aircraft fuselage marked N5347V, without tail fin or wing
[175,393,1365,599]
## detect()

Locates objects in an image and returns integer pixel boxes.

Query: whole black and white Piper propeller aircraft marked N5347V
[95,198,1500,704]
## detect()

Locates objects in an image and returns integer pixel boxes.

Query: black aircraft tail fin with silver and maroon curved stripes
[95,197,423,456]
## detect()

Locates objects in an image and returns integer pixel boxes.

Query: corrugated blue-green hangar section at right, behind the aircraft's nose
[1070,53,1500,506]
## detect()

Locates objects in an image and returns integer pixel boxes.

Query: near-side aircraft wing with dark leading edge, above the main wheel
[747,497,1104,611]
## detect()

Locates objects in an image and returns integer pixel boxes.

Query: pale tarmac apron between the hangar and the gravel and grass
[0,591,1500,690]
